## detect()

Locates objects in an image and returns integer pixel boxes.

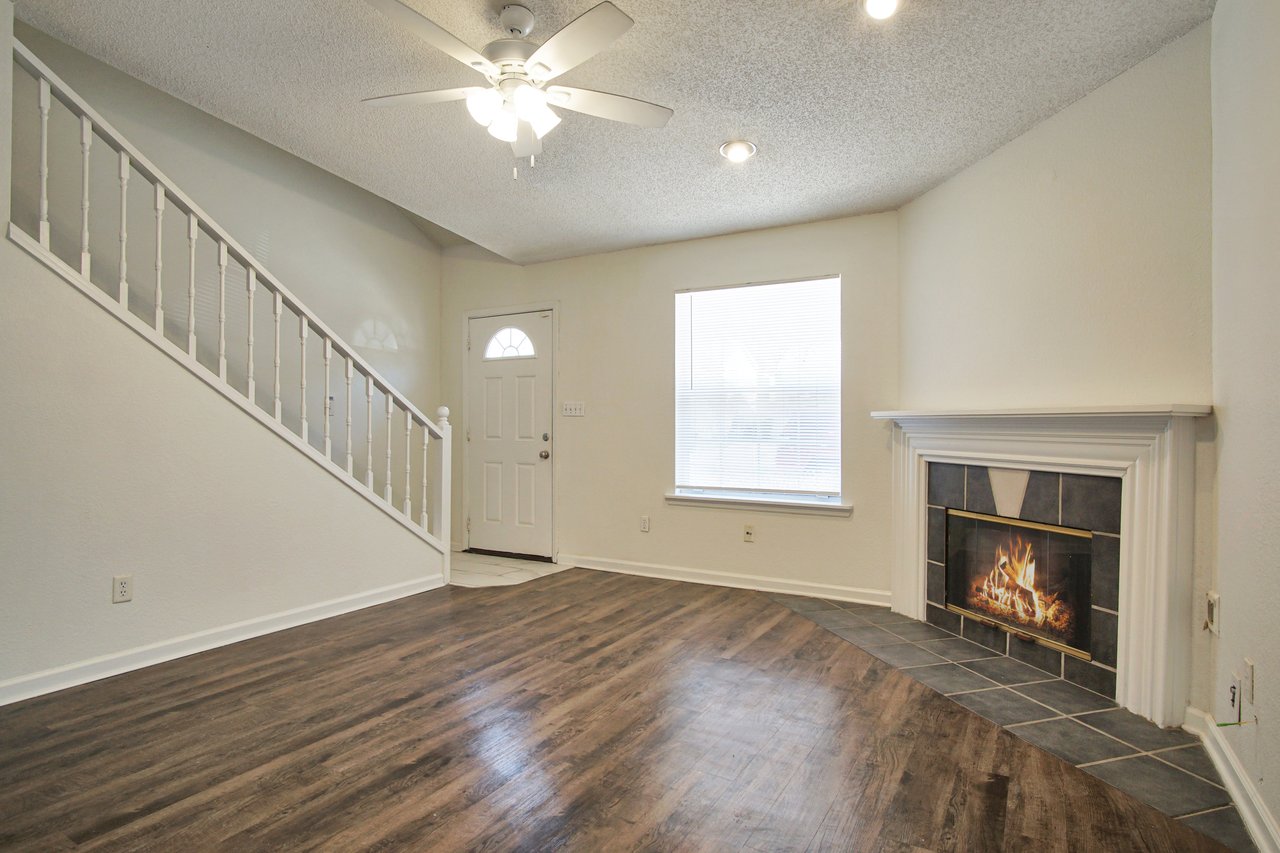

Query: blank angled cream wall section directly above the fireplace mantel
[900,24,1211,409]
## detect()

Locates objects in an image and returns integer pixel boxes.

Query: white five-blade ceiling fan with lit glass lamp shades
[364,0,672,158]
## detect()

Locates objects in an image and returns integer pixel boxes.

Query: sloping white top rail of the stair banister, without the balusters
[13,38,444,438]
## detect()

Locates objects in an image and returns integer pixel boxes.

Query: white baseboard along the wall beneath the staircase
[0,574,444,706]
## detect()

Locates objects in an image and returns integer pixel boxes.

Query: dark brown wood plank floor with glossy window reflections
[0,570,1225,852]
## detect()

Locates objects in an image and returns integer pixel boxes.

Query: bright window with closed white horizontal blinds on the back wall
[669,278,844,507]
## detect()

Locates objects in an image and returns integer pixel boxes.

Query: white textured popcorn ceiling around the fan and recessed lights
[17,0,1213,263]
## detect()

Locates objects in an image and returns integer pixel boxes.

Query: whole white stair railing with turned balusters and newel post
[9,38,452,550]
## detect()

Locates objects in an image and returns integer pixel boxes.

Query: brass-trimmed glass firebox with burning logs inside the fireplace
[946,508,1093,661]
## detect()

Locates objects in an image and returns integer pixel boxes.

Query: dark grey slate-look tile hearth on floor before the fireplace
[771,594,1257,850]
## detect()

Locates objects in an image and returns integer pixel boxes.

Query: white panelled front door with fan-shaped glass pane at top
[465,311,553,557]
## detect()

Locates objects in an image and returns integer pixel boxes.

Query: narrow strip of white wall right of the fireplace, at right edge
[1210,0,1280,820]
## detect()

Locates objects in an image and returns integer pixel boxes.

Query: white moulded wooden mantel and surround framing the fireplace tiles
[872,405,1212,726]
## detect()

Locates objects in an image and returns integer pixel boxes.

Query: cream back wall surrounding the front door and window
[442,214,897,596]
